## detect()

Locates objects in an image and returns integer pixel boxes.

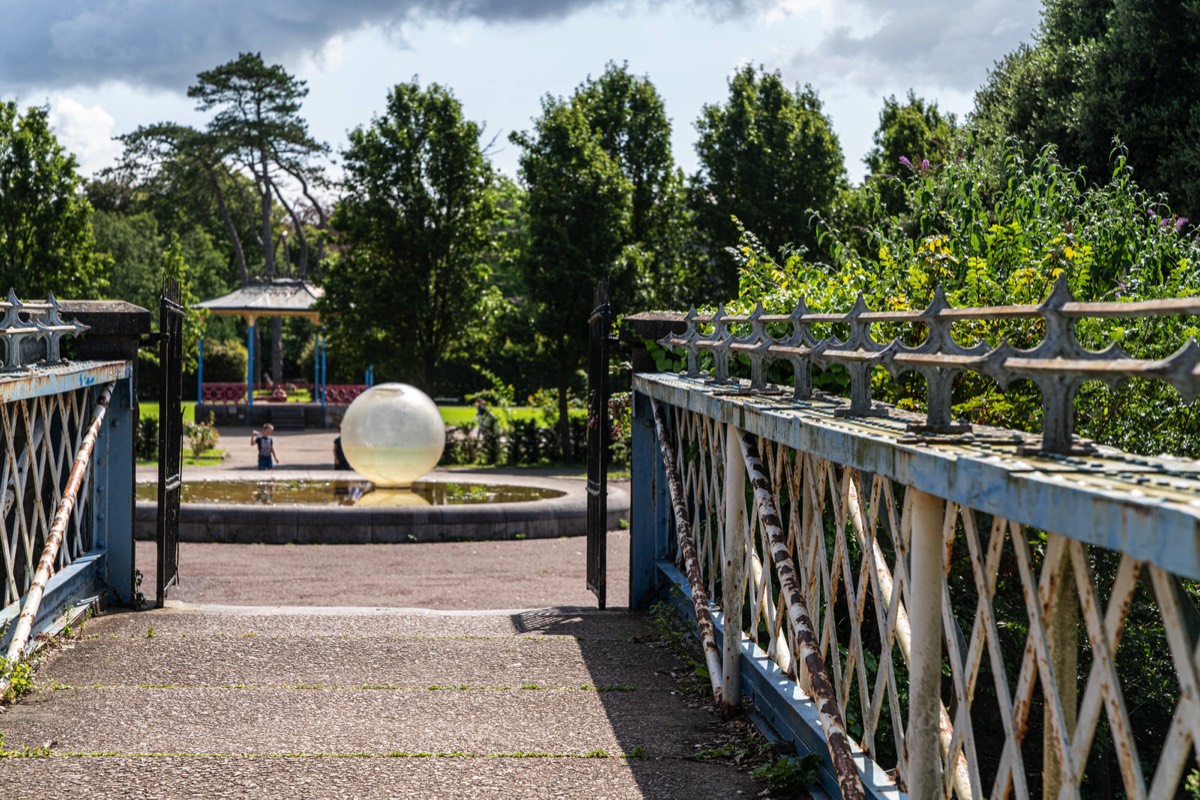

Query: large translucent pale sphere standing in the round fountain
[342,384,446,487]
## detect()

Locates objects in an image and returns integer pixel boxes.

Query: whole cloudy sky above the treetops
[0,0,1040,181]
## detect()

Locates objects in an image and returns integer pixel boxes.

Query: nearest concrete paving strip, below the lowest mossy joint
[0,758,758,800]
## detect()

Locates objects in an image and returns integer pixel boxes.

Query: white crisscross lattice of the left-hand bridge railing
[0,389,95,607]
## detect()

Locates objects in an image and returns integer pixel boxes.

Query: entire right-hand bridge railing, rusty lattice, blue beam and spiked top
[631,277,1200,799]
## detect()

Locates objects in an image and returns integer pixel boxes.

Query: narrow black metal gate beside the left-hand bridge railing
[156,282,184,608]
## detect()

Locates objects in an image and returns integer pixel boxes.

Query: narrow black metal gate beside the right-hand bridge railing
[588,281,612,608]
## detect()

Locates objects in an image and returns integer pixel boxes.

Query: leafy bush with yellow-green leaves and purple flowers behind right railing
[732,141,1200,456]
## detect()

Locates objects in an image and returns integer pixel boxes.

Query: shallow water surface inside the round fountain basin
[137,479,563,506]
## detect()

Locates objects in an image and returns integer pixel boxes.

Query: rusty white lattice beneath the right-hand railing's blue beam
[671,408,1200,799]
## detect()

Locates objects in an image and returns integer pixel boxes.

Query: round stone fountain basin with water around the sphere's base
[134,470,629,545]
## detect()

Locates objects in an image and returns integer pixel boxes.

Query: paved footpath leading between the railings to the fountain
[0,429,761,800]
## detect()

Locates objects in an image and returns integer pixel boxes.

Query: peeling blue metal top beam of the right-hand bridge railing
[634,374,1200,579]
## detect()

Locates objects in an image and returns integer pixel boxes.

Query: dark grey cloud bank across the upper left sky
[0,0,748,91]
